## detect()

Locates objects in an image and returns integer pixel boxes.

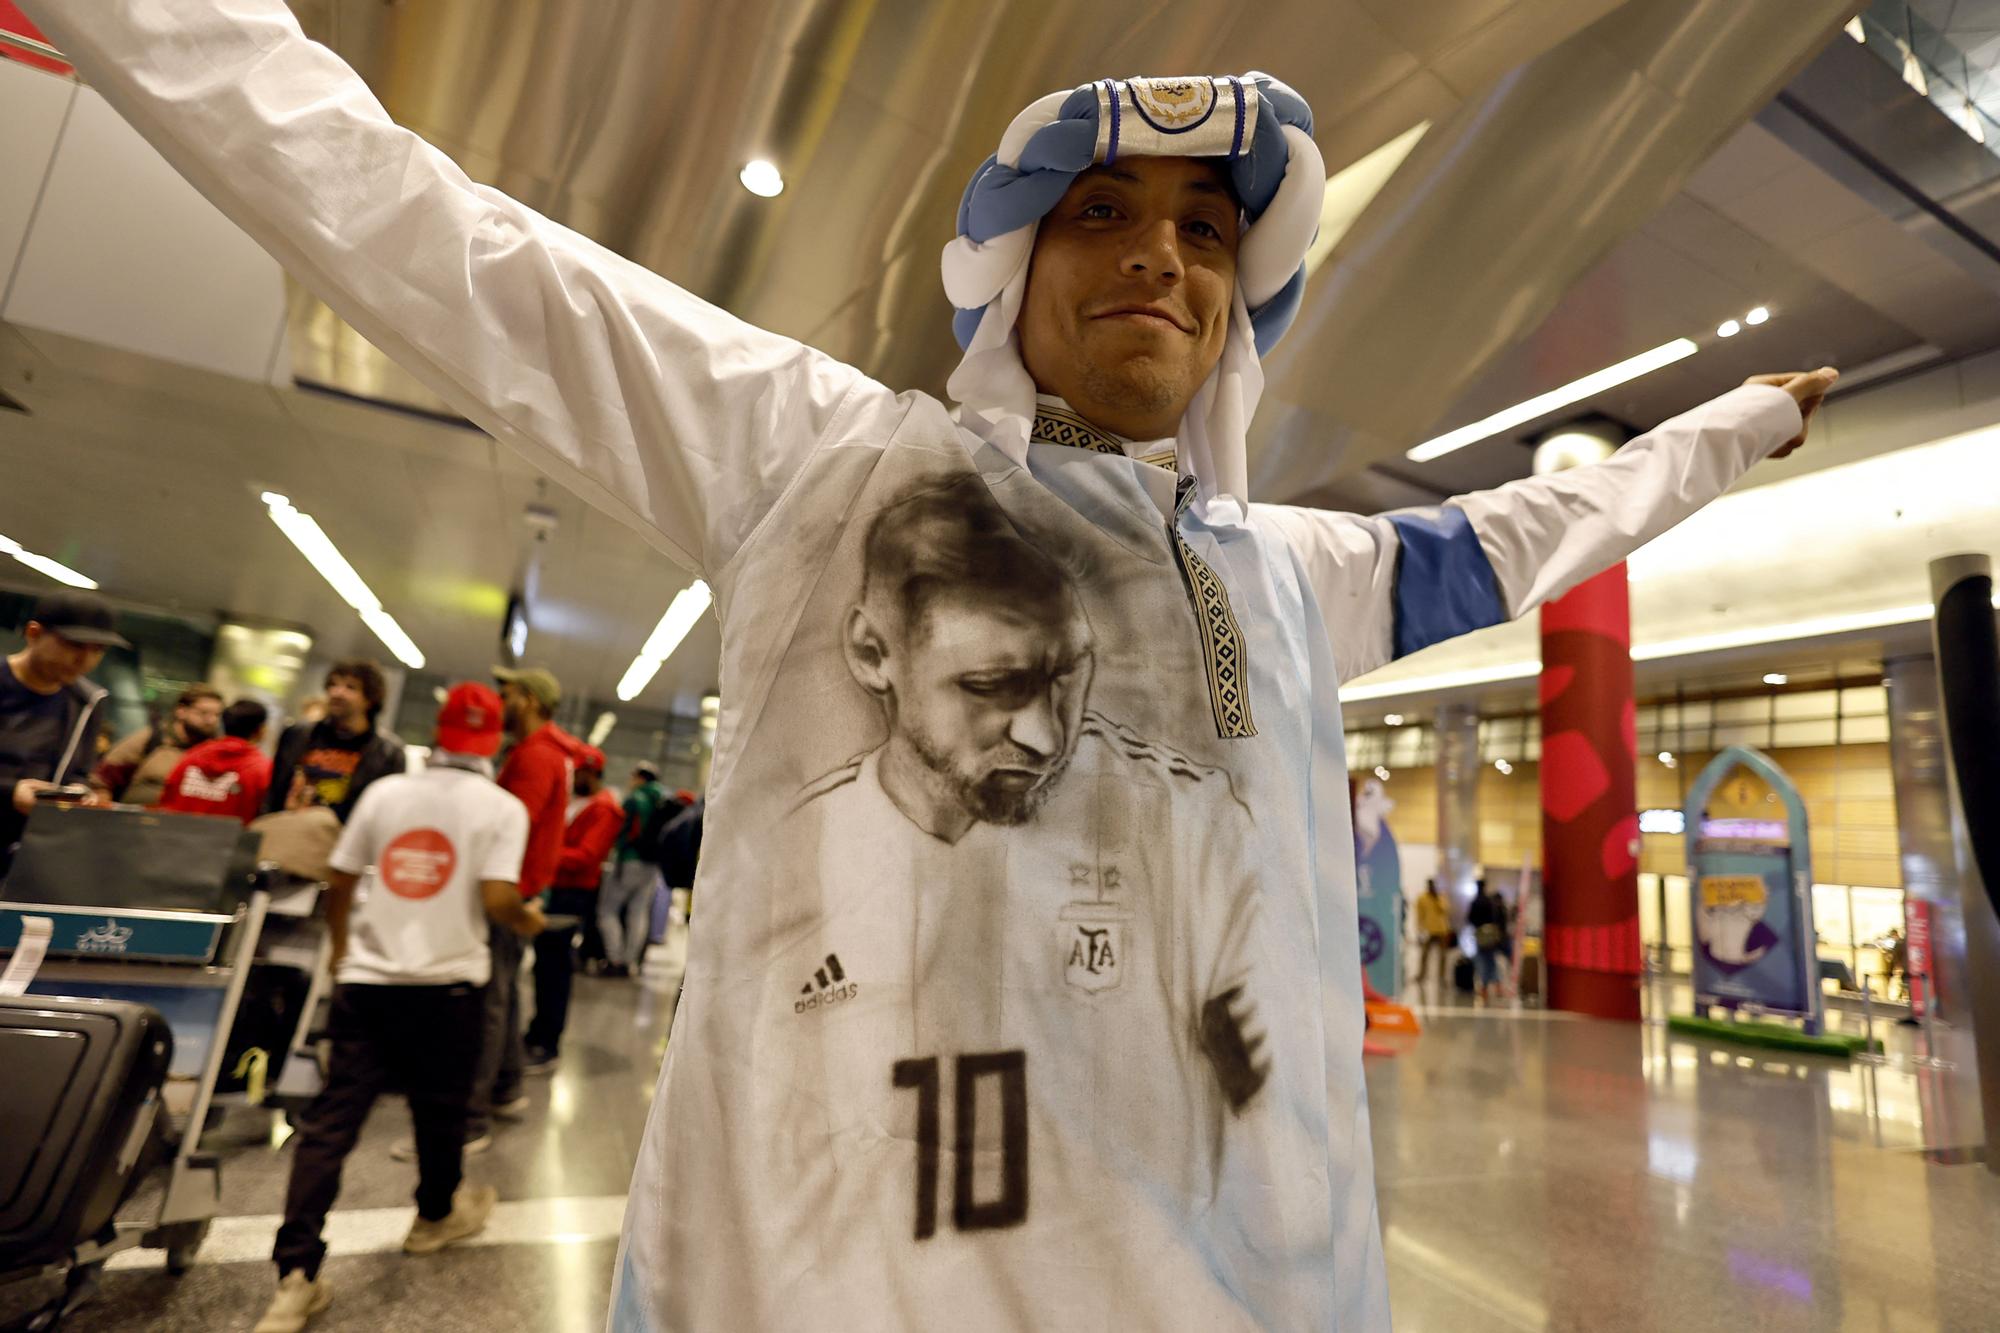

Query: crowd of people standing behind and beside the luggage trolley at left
[0,590,700,1333]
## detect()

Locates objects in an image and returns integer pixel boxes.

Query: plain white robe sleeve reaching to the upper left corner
[22,0,890,570]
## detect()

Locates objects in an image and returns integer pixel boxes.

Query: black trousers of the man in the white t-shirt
[270,985,484,1279]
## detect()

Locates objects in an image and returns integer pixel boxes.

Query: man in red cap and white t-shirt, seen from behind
[256,683,544,1333]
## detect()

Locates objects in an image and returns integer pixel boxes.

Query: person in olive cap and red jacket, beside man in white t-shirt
[466,667,578,1141]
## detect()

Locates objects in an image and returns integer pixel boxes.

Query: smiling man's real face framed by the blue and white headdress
[1020,158,1240,440]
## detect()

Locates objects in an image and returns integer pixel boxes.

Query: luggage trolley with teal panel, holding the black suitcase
[0,809,280,1309]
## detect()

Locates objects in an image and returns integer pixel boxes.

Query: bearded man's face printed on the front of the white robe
[884,592,1094,825]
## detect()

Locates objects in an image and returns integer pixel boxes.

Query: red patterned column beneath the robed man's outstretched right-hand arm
[1542,564,1640,1021]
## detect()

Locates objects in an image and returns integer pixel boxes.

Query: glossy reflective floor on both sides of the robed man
[15,940,2000,1333]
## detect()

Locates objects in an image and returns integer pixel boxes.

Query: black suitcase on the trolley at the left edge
[0,995,174,1275]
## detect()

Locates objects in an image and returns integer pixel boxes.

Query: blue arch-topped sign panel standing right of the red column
[1686,745,1822,1033]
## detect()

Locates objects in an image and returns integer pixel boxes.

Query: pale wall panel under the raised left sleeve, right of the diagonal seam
[0,88,284,380]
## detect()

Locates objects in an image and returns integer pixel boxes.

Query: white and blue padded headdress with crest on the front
[944,72,1326,500]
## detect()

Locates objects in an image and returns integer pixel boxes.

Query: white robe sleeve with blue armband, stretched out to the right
[1252,384,1800,681]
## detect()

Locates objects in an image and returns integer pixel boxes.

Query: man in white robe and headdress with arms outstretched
[22,0,1832,1329]
